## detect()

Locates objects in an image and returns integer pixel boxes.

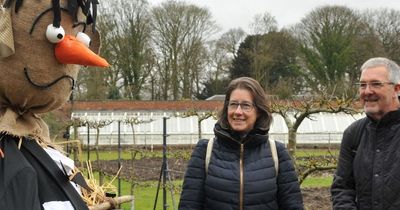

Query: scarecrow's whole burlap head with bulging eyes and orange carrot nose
[0,0,108,143]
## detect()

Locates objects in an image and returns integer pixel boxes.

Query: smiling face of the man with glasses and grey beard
[359,66,400,120]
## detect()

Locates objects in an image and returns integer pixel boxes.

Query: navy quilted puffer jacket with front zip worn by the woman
[179,125,303,210]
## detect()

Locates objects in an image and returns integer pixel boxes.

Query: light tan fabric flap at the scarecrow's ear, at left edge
[0,5,15,58]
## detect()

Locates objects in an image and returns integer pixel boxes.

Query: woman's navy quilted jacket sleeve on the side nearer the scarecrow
[179,140,208,210]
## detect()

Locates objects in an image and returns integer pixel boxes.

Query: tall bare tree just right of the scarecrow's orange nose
[94,0,154,100]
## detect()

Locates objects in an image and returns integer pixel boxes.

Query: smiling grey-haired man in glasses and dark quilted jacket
[331,58,400,210]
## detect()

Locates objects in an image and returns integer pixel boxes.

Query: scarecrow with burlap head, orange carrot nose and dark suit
[0,0,128,210]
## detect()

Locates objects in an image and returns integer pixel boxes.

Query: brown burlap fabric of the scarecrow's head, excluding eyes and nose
[0,0,104,141]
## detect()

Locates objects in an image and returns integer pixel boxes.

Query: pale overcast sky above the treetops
[148,0,400,32]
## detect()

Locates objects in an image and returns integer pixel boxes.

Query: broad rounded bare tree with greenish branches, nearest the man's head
[293,6,382,95]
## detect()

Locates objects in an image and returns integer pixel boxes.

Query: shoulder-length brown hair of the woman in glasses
[218,77,272,130]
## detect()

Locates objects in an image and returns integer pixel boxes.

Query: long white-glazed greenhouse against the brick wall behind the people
[71,110,364,146]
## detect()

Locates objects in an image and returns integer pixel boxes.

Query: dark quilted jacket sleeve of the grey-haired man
[331,123,357,209]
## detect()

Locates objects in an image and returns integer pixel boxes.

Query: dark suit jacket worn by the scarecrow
[0,135,88,210]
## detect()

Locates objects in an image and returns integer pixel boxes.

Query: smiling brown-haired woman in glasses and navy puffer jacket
[179,77,303,210]
